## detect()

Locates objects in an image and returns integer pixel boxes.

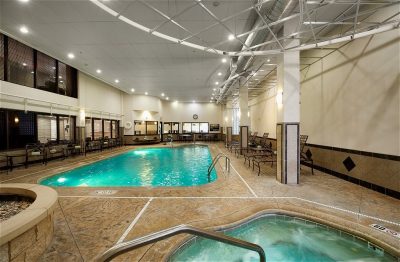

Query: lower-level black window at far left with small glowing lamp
[8,111,36,149]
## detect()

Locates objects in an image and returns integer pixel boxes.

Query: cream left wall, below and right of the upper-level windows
[0,72,122,119]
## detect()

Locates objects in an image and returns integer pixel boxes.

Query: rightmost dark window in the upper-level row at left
[57,62,78,98]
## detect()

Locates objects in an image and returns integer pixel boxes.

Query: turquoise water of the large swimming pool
[40,145,217,187]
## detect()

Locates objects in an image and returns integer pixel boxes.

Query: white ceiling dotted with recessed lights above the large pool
[0,0,396,101]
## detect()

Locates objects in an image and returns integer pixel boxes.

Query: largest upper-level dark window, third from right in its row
[7,38,35,87]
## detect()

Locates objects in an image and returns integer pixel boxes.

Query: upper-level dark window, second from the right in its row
[36,52,57,93]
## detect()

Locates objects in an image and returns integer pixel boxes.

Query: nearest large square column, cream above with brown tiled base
[276,19,300,184]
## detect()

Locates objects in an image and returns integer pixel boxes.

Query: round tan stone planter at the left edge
[0,184,58,261]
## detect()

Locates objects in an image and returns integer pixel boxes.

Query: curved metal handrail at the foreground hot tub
[95,225,265,262]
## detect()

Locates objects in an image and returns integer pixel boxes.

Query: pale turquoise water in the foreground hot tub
[170,215,397,262]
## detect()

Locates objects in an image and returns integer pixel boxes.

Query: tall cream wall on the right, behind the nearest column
[250,30,400,155]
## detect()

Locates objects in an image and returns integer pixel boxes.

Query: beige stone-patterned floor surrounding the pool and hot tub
[0,143,400,261]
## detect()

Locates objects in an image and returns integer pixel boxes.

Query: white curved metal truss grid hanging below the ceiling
[90,0,400,56]
